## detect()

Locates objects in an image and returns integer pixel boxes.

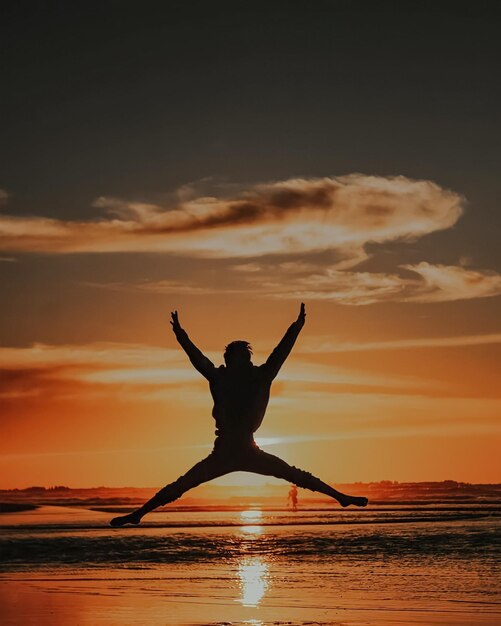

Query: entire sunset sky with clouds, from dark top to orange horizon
[0,0,501,488]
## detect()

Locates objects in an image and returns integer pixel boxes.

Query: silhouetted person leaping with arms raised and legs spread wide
[110,303,367,526]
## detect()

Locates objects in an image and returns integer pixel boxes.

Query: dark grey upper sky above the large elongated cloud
[0,0,500,253]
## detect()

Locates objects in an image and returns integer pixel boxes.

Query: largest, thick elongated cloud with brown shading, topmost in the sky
[0,174,464,267]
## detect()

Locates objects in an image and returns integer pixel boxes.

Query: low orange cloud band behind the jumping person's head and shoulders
[0,343,429,399]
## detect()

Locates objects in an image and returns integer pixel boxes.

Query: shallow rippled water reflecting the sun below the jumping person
[0,504,501,626]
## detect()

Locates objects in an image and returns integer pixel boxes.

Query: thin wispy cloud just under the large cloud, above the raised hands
[89,261,501,306]
